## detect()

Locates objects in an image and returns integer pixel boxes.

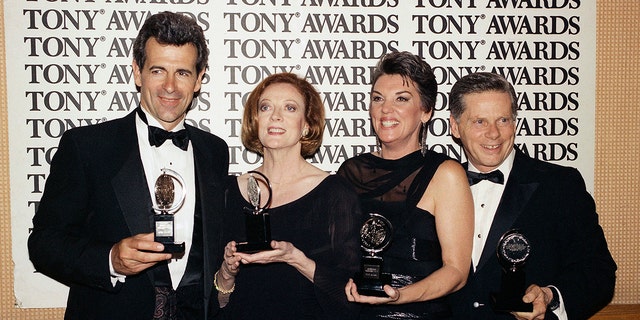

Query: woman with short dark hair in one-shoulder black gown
[338,52,473,319]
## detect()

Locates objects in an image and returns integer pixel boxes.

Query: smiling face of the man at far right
[450,91,516,172]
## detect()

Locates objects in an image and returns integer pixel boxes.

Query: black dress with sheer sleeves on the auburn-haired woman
[222,176,362,320]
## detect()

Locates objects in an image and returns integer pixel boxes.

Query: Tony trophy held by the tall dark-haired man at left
[153,168,187,253]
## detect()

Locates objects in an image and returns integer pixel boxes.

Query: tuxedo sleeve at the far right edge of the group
[550,168,617,319]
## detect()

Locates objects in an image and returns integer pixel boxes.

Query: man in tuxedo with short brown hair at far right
[449,73,617,320]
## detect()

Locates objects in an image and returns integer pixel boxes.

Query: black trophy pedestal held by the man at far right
[491,270,533,312]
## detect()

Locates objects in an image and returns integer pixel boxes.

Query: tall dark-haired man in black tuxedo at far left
[28,12,229,320]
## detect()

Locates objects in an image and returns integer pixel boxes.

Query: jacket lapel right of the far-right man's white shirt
[477,155,538,270]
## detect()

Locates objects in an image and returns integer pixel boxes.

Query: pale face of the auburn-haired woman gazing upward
[258,83,307,149]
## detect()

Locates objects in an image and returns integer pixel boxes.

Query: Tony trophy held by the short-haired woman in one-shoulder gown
[354,213,393,297]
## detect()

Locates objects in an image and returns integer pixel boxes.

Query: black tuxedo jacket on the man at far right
[449,149,617,320]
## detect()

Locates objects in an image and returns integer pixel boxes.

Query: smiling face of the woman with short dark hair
[369,74,431,153]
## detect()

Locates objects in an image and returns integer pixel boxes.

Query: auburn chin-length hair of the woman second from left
[241,73,325,158]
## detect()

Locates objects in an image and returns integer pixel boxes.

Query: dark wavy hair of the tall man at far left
[133,11,209,74]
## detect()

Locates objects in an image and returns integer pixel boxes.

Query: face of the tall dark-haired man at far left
[133,38,204,130]
